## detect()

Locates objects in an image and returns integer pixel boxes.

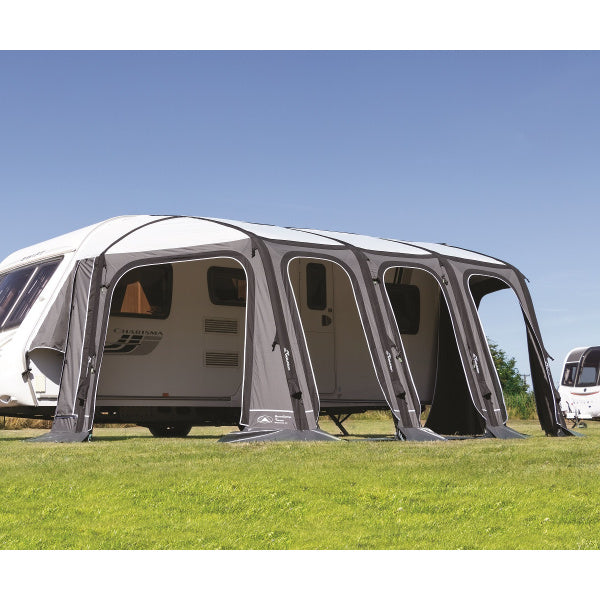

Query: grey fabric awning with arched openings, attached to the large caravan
[30,217,564,440]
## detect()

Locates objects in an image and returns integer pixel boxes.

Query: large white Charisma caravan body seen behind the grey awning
[0,217,388,436]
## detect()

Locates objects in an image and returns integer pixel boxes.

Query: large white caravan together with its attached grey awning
[0,215,569,441]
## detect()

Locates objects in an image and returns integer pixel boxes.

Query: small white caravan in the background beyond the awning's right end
[558,346,600,424]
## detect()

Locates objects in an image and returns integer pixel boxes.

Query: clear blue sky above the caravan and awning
[0,51,600,376]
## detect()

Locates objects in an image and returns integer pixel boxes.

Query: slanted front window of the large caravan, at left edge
[0,258,62,330]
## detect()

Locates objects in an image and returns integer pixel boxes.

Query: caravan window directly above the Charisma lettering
[110,265,173,319]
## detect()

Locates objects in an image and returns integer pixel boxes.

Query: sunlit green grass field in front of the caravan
[0,415,600,549]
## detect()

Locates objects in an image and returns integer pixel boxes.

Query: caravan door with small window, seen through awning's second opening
[297,259,336,394]
